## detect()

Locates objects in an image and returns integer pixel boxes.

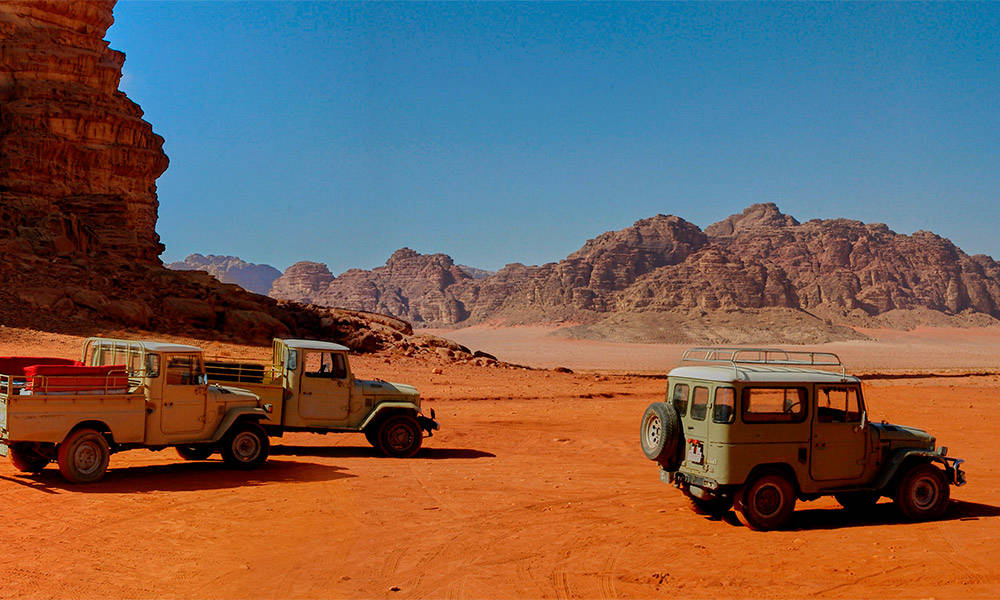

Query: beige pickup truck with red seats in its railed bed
[0,338,271,483]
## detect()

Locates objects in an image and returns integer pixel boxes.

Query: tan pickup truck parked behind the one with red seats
[206,339,439,458]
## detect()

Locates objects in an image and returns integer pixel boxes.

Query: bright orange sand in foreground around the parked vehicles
[0,330,1000,598]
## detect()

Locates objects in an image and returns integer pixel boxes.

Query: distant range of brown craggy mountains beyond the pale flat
[271,204,1000,343]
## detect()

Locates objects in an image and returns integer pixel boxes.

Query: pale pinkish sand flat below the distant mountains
[422,325,1000,373]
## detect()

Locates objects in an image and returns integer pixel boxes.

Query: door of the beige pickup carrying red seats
[160,354,208,434]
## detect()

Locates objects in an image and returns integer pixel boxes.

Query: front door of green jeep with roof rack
[809,385,868,481]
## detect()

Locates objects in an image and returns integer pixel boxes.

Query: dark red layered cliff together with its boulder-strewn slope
[0,0,458,350]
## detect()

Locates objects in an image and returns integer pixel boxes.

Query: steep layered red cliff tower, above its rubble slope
[0,0,167,264]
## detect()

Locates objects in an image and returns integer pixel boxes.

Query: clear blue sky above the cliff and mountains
[107,1,1000,273]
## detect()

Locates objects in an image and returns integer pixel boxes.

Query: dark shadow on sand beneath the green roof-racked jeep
[723,500,1000,531]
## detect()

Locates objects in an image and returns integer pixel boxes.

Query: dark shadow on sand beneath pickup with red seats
[0,459,357,494]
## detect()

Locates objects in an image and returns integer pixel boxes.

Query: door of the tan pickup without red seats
[299,351,352,421]
